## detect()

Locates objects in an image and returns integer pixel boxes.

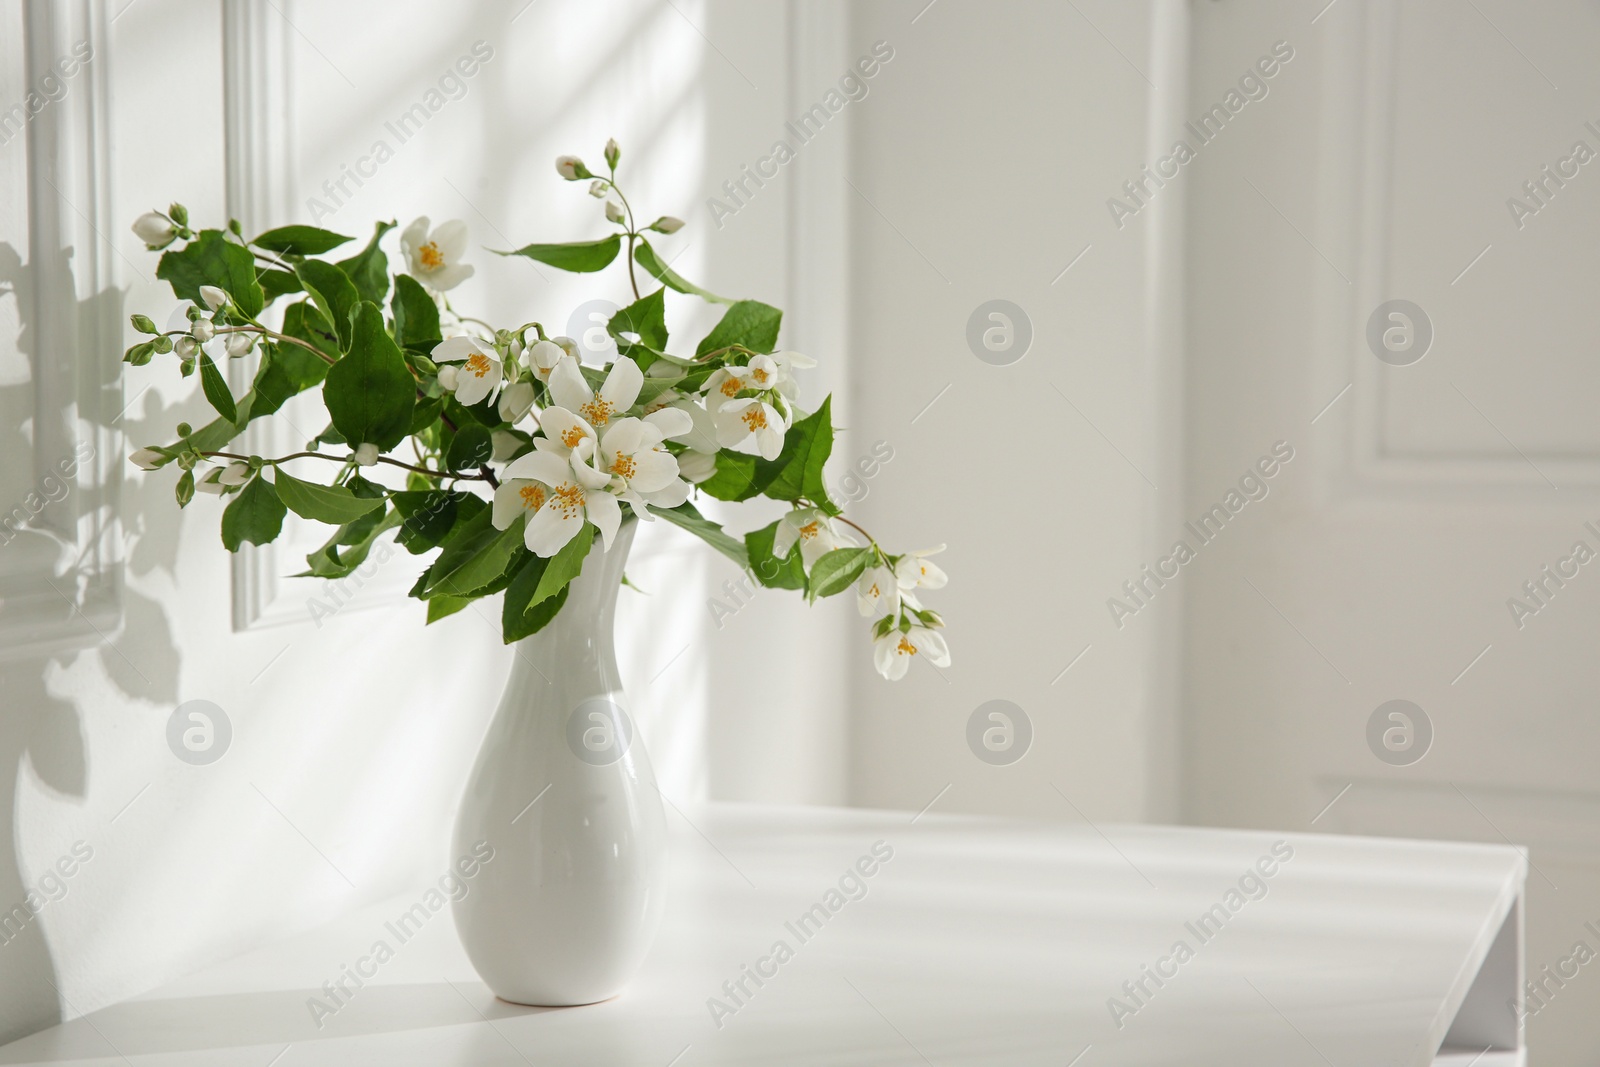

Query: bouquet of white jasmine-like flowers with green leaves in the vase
[125,141,949,678]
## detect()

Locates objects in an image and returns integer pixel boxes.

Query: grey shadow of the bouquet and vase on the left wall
[0,242,178,1043]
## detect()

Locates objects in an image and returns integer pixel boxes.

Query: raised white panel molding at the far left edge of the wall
[0,0,121,657]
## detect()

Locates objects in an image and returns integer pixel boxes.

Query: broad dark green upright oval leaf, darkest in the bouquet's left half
[321,300,416,450]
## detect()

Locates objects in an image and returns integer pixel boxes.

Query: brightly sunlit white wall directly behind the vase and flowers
[0,0,864,1040]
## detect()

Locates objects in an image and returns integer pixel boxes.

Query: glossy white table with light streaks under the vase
[0,805,1526,1067]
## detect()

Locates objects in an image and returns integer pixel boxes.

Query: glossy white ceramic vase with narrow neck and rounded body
[451,520,667,1005]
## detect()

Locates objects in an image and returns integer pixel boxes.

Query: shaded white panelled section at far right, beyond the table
[1184,0,1600,1065]
